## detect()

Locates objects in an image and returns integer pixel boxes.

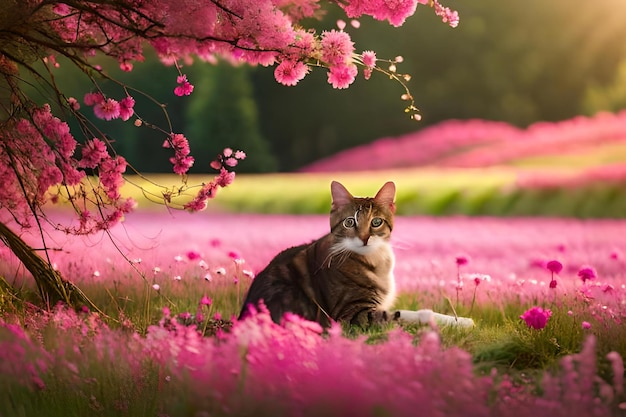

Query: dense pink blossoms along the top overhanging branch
[44,0,459,105]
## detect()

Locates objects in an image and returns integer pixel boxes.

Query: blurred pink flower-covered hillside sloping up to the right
[301,111,626,177]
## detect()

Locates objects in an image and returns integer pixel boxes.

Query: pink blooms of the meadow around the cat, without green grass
[0,213,626,417]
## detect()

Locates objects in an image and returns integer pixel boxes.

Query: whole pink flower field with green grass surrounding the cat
[0,210,626,417]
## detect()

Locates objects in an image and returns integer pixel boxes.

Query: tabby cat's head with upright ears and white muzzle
[330,181,396,255]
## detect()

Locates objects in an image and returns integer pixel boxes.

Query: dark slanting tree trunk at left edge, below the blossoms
[0,222,99,311]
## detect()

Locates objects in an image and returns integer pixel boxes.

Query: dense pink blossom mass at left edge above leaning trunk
[0,105,134,234]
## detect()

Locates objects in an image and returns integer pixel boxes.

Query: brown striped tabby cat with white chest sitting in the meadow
[239,181,396,328]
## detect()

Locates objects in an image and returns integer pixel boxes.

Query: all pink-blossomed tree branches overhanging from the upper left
[0,0,458,234]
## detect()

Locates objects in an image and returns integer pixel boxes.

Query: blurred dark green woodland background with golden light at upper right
[37,0,626,173]
